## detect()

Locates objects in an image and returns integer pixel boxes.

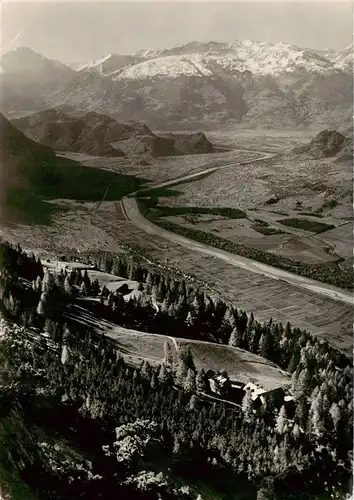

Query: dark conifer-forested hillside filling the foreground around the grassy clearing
[0,243,353,500]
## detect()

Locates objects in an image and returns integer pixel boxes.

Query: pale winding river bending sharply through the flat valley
[121,152,353,304]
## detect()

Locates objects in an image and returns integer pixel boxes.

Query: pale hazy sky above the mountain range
[0,0,353,62]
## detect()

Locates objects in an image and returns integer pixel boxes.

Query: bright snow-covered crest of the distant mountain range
[110,40,340,80]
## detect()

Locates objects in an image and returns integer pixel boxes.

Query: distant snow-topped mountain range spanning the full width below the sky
[0,41,353,129]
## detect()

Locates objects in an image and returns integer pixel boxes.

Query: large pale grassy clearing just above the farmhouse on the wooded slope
[68,307,290,389]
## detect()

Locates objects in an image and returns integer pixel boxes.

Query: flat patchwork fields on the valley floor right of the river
[152,148,352,274]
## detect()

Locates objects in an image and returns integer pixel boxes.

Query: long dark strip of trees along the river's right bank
[137,198,354,290]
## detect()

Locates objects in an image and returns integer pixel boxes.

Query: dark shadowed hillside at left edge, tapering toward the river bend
[0,114,144,224]
